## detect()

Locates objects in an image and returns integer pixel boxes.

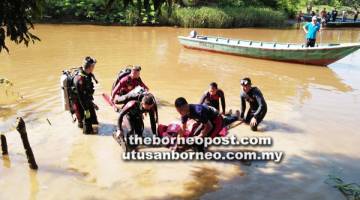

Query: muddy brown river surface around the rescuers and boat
[0,25,360,200]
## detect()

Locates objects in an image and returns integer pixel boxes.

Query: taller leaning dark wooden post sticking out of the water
[16,117,38,170]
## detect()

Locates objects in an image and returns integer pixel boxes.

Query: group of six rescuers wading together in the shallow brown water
[64,57,267,148]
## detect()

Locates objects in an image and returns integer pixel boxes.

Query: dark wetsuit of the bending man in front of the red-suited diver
[118,100,157,137]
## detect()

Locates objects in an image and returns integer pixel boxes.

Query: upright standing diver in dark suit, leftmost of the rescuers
[73,56,99,134]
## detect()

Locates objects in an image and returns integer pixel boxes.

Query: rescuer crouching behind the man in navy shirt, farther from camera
[200,82,226,115]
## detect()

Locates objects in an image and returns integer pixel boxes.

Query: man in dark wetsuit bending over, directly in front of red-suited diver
[114,94,158,150]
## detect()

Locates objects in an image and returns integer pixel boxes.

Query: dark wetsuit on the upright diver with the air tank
[73,68,98,134]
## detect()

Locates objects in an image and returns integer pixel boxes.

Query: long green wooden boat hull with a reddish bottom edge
[179,36,360,66]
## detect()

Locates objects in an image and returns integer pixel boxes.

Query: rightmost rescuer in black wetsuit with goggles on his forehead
[240,78,267,131]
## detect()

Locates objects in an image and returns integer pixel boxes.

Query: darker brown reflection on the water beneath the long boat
[178,49,352,104]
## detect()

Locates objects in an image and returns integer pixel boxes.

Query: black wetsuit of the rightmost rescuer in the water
[240,87,267,130]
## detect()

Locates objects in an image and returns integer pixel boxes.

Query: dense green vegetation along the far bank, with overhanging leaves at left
[0,0,359,52]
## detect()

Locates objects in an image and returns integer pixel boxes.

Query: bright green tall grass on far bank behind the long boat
[161,7,286,28]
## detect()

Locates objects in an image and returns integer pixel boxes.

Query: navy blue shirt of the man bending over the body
[181,104,219,124]
